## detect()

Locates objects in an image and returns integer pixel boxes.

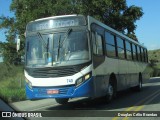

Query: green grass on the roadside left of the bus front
[0,63,26,102]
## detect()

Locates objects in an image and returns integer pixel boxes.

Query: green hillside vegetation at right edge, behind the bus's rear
[148,49,160,77]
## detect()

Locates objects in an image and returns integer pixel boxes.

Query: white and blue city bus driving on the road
[24,15,150,104]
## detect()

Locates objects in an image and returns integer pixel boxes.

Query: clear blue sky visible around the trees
[0,0,160,50]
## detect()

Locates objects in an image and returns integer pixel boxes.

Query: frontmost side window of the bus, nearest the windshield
[92,33,103,55]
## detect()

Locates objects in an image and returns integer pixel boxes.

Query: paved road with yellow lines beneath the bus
[11,78,160,120]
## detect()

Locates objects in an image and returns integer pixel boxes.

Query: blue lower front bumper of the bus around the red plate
[26,77,94,99]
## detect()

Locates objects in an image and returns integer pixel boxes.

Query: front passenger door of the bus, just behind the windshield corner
[92,32,106,97]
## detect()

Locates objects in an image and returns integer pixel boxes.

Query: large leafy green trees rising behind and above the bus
[0,0,143,62]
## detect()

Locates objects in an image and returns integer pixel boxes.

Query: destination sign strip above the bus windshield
[27,16,86,31]
